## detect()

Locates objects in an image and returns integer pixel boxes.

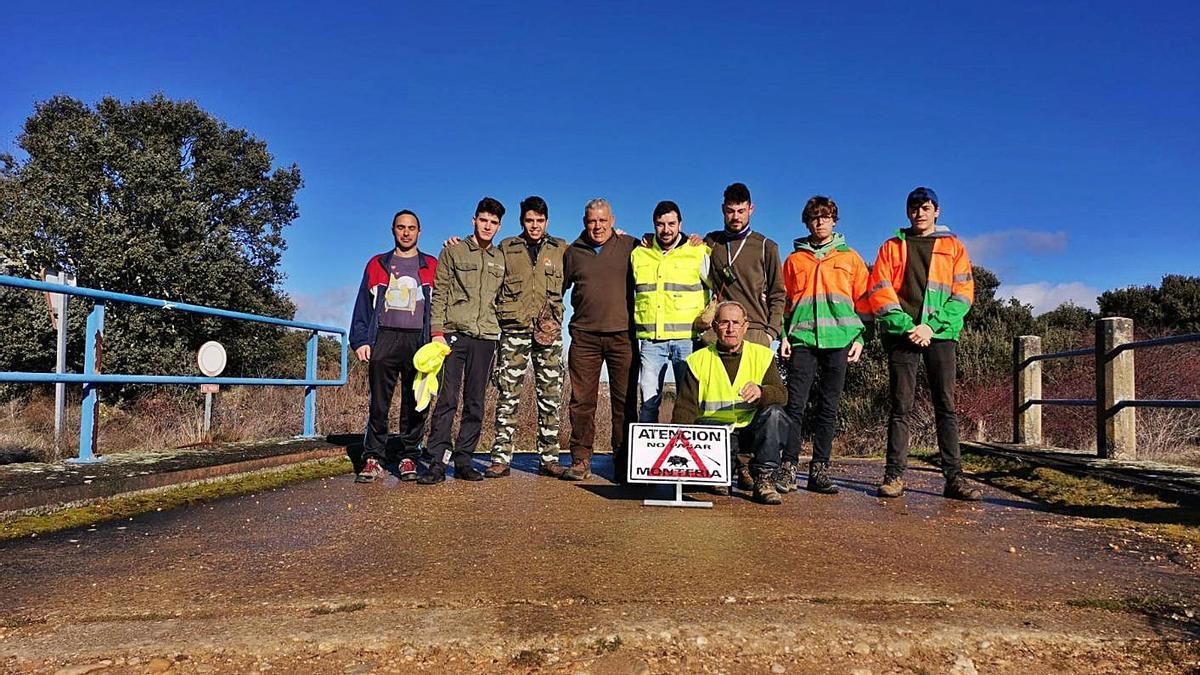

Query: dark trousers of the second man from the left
[430,333,496,467]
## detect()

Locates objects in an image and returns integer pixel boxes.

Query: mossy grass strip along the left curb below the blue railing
[0,458,350,542]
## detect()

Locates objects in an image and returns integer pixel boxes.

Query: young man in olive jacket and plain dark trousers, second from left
[416,197,504,485]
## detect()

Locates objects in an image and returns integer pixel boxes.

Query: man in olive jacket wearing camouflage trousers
[484,197,566,478]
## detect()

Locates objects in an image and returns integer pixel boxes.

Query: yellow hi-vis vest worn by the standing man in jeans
[630,239,708,340]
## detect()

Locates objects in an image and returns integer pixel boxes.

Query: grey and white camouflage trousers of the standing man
[492,333,563,464]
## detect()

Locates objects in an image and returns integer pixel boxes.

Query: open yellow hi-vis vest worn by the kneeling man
[688,341,775,429]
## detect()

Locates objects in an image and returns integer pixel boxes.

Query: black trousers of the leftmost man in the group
[362,327,426,461]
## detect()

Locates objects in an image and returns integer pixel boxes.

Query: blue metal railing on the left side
[0,275,349,464]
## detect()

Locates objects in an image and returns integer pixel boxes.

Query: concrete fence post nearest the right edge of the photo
[1096,317,1138,459]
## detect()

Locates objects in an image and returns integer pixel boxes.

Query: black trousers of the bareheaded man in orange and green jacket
[784,346,850,464]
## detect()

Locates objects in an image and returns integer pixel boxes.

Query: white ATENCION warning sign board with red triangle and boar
[628,424,730,485]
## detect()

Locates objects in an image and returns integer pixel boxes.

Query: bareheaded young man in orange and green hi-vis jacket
[775,196,870,495]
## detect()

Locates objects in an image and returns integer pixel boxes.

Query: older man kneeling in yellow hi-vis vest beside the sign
[671,300,791,504]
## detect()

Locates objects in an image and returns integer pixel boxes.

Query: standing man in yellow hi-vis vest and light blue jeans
[630,201,709,423]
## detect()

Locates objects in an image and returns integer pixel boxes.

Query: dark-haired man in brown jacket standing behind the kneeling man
[703,183,787,347]
